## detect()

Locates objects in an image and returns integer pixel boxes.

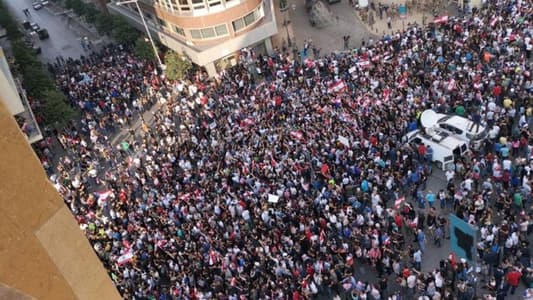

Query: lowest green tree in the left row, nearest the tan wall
[42,89,75,129]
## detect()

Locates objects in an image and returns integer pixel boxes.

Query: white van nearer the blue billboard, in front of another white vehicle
[406,128,468,171]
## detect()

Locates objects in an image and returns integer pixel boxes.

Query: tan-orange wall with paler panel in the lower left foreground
[0,101,121,300]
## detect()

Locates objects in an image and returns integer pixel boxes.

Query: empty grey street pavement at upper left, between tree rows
[7,0,90,63]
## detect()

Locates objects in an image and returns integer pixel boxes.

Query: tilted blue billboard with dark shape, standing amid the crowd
[449,214,478,265]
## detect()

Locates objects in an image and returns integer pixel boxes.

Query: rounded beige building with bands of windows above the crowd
[107,0,277,75]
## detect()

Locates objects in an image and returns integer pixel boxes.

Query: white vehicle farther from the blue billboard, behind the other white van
[435,114,488,150]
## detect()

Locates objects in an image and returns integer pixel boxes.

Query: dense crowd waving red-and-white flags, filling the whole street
[32,0,533,300]
